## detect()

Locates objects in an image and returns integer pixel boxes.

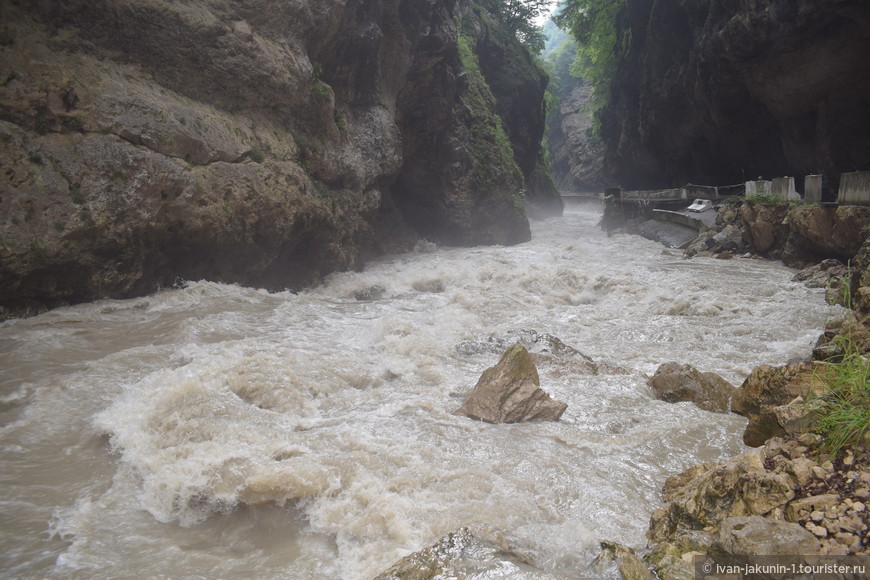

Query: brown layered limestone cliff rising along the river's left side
[0,0,546,316]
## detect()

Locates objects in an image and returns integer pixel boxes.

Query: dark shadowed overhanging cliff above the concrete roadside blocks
[602,0,870,188]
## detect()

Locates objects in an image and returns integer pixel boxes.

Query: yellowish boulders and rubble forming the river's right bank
[644,211,870,579]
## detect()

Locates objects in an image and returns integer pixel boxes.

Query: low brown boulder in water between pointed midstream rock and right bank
[648,362,736,413]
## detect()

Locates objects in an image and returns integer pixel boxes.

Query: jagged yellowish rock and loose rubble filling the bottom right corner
[644,433,870,578]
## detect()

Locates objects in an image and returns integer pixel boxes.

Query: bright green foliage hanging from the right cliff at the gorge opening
[553,0,631,108]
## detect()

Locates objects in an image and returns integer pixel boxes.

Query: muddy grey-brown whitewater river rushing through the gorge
[0,207,829,580]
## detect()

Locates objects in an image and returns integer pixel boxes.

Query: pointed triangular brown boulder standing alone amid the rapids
[456,344,568,423]
